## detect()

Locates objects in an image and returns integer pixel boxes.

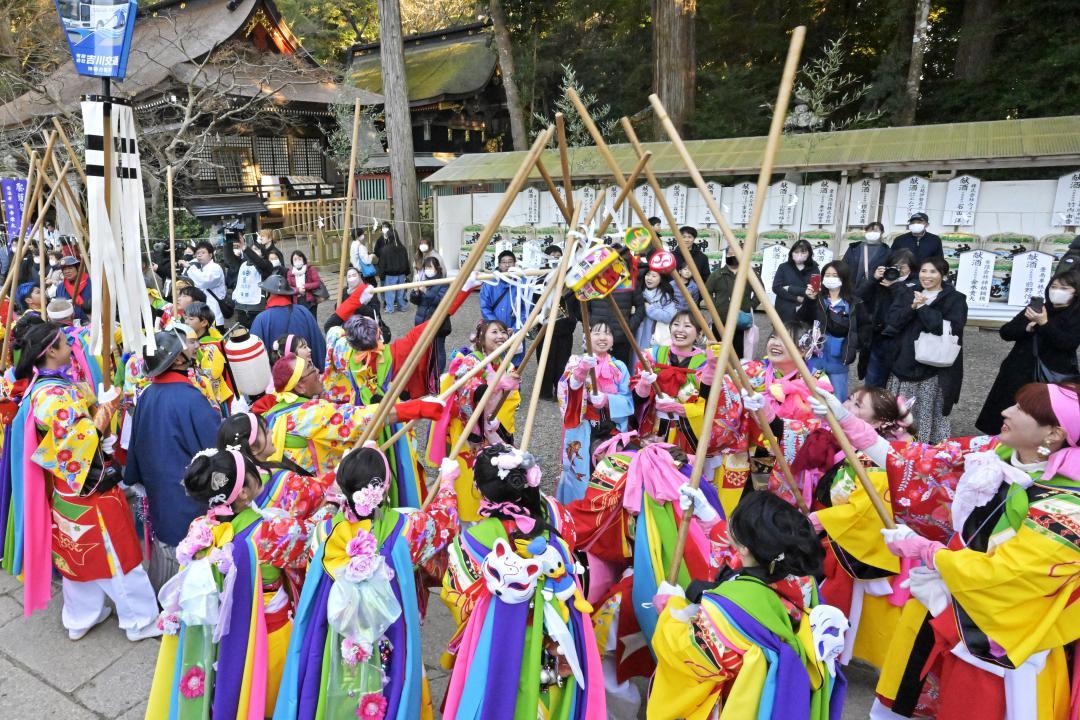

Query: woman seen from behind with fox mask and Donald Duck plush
[443,445,607,720]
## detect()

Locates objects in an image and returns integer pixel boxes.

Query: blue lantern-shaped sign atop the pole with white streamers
[55,0,138,80]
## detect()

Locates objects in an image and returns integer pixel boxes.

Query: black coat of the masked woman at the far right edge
[975,299,1080,435]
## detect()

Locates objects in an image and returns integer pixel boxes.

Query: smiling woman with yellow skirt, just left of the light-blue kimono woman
[428,320,522,522]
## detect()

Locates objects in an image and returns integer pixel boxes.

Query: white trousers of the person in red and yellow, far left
[60,565,158,633]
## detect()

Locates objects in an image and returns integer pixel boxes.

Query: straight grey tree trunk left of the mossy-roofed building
[373,0,420,250]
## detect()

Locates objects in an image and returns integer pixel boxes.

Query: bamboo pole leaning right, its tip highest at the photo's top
[665,26,806,584]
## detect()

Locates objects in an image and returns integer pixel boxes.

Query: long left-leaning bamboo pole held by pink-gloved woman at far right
[650,92,895,528]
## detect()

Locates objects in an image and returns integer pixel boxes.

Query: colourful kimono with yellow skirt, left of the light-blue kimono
[428,349,522,522]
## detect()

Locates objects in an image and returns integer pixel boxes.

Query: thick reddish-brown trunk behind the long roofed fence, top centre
[652,0,698,136]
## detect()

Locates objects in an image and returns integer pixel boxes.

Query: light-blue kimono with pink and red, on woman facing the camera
[555,355,634,504]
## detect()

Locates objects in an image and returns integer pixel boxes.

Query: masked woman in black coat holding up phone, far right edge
[975,267,1080,435]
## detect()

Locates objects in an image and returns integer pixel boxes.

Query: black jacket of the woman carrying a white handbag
[885,285,968,416]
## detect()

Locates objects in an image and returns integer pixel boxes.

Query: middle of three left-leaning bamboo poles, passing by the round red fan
[622,118,810,515]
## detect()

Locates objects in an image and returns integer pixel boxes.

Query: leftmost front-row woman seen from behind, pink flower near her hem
[146,447,308,720]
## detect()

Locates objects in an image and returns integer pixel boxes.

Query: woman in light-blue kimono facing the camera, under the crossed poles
[555,323,634,504]
